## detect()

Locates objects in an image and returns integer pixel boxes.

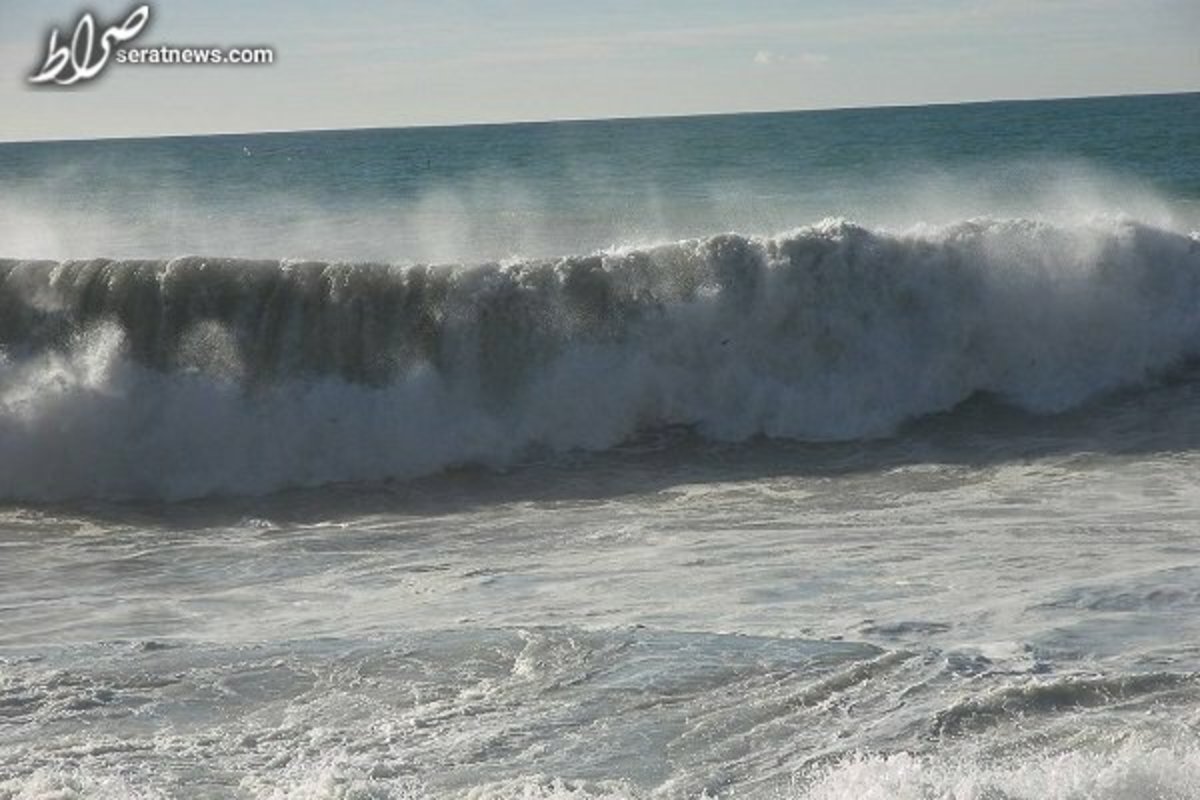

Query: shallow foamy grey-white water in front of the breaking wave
[7,388,1200,798]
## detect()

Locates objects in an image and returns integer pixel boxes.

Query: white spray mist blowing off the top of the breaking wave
[0,144,1200,265]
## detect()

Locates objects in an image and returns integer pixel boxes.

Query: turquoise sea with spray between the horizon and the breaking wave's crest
[0,95,1200,263]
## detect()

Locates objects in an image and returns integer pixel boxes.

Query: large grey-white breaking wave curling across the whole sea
[0,218,1200,499]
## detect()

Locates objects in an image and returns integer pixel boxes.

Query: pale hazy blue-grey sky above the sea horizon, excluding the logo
[0,0,1200,140]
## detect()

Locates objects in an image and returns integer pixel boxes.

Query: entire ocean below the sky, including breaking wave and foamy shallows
[0,95,1200,800]
